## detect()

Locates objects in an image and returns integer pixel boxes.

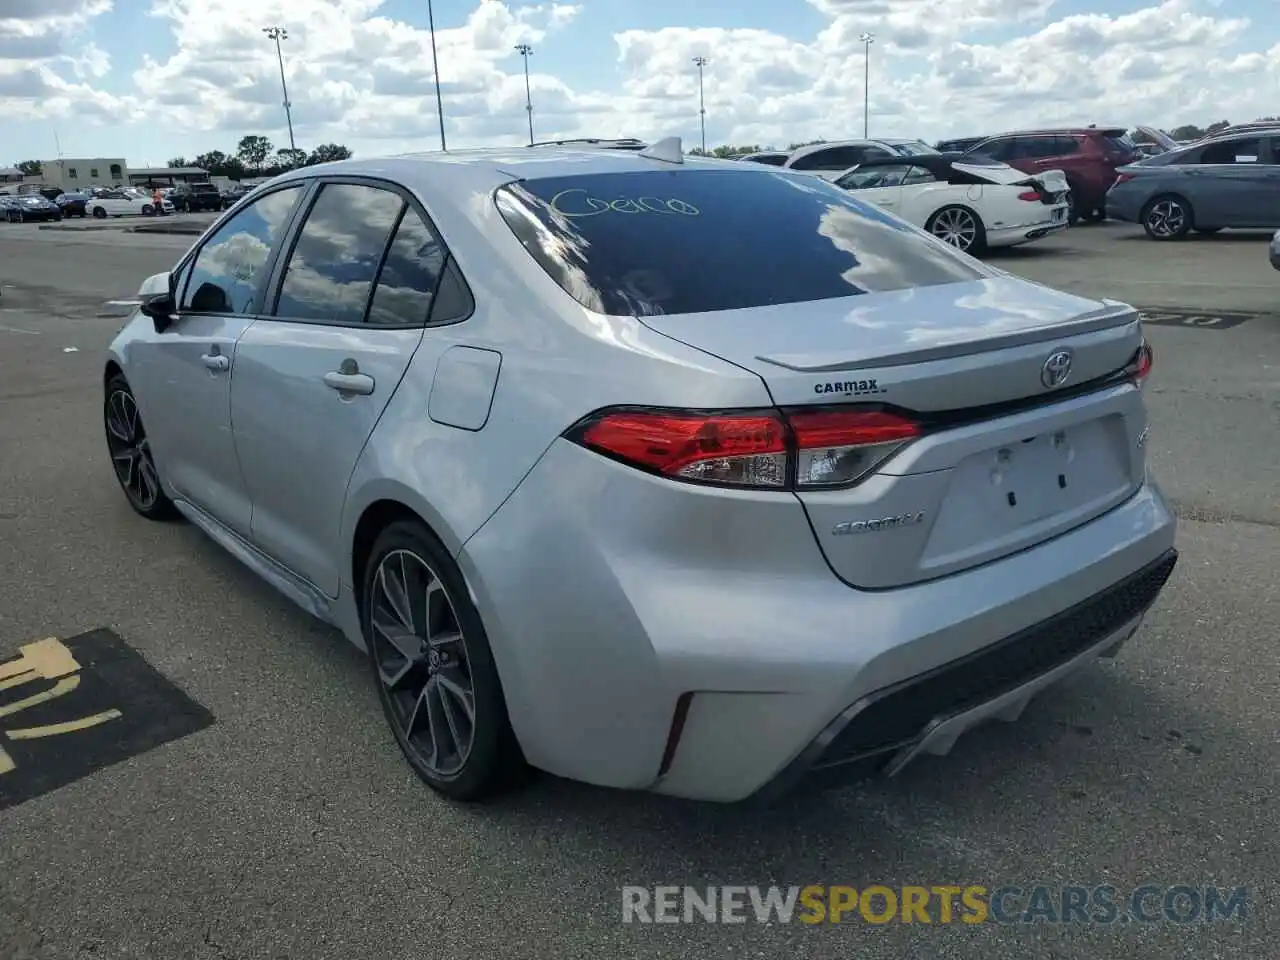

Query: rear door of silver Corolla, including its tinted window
[232,178,445,596]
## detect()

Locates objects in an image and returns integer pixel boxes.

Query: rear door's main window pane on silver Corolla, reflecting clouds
[275,183,404,324]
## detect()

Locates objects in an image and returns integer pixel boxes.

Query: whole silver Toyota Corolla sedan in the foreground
[104,141,1176,801]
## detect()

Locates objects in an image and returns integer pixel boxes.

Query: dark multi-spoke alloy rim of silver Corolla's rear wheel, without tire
[369,549,476,780]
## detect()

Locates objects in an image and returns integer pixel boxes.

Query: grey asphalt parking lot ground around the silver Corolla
[0,224,1280,960]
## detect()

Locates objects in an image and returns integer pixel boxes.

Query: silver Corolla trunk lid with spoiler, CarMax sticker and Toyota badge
[640,278,1146,589]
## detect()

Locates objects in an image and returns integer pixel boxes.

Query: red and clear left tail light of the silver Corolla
[566,407,922,490]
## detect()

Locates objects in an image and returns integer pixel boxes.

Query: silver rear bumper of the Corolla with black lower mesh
[458,442,1175,801]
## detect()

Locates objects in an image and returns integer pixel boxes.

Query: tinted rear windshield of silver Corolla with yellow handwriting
[497,165,987,316]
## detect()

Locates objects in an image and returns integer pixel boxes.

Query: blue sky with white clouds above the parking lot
[0,0,1280,166]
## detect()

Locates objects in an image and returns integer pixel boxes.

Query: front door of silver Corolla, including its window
[129,186,302,538]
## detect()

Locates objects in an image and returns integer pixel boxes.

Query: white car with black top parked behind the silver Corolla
[836,154,1070,253]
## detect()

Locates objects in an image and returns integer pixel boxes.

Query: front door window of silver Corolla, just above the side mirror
[180,184,302,314]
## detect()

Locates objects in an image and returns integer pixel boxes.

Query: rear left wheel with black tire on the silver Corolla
[361,521,526,801]
